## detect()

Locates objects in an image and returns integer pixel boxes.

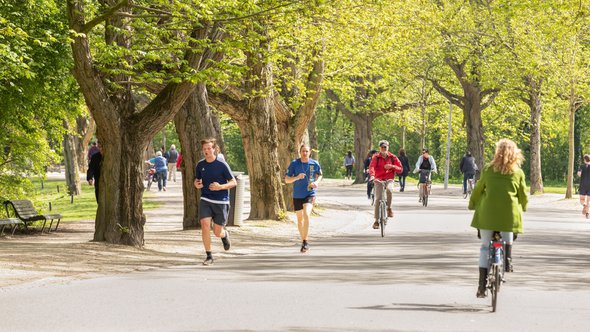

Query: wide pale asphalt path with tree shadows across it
[0,181,590,332]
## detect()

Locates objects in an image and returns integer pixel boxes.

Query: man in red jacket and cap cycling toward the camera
[369,140,403,229]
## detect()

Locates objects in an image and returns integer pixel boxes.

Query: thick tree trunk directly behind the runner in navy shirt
[174,83,223,229]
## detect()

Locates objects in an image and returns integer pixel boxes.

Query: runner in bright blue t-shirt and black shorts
[285,145,322,253]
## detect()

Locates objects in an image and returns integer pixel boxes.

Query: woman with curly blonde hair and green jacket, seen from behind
[469,139,528,297]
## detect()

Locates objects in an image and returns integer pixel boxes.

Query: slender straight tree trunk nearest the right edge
[525,76,543,195]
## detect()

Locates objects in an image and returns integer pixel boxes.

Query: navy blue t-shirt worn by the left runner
[195,159,234,204]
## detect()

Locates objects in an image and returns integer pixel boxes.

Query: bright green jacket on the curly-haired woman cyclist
[469,166,528,234]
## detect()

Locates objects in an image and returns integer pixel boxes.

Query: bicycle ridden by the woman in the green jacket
[486,231,506,312]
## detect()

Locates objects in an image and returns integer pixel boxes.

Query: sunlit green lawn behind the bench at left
[30,179,160,221]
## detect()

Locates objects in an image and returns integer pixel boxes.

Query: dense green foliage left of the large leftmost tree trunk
[0,0,81,198]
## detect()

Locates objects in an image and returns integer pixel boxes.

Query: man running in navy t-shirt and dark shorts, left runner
[194,138,237,265]
